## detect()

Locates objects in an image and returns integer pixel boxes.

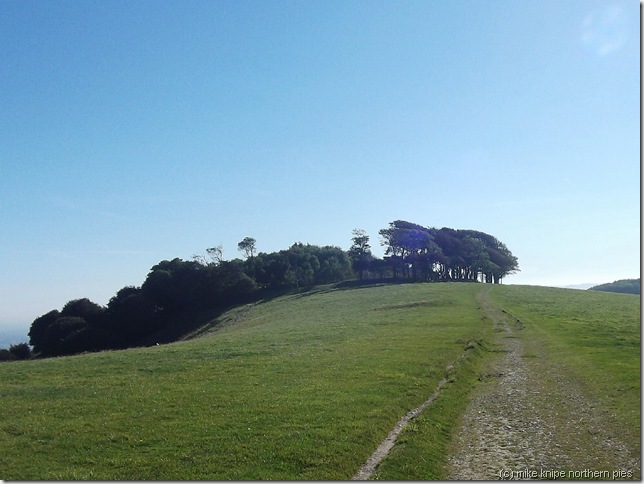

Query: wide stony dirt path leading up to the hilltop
[448,293,641,480]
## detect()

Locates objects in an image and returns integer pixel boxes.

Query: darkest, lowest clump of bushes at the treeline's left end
[29,258,255,356]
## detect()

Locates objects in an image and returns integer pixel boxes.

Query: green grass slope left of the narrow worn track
[0,284,486,480]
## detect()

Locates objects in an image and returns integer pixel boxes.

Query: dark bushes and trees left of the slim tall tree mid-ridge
[29,241,353,357]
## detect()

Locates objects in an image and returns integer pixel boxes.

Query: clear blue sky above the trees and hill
[0,0,640,340]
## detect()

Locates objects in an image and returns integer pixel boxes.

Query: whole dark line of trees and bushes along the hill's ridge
[29,220,518,357]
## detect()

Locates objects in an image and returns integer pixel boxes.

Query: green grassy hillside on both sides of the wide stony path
[0,283,640,480]
